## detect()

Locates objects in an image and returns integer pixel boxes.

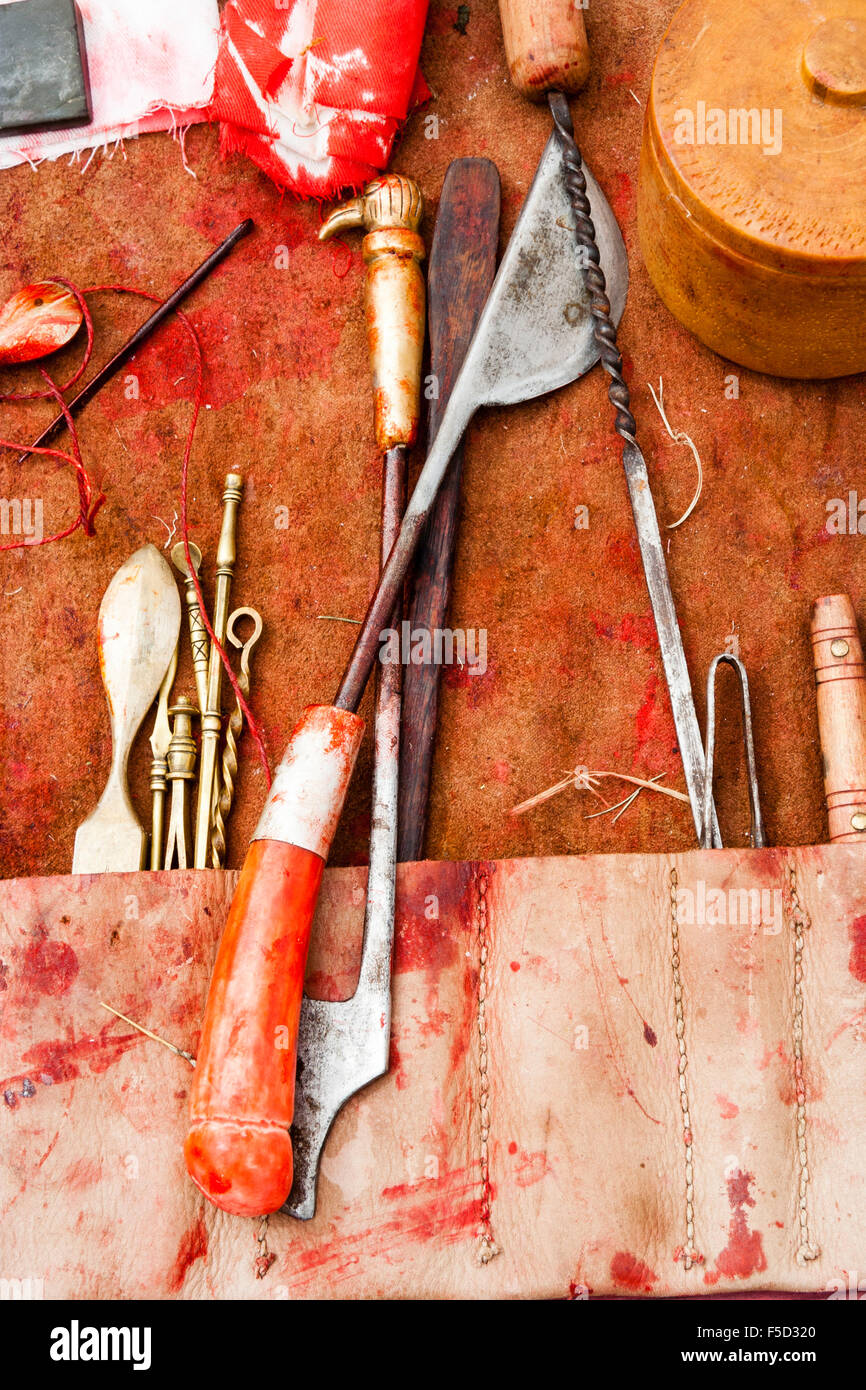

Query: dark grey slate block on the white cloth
[0,0,91,131]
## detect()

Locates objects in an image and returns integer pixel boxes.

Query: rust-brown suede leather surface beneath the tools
[0,0,866,876]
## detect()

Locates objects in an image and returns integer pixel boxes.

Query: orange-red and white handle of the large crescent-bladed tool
[183,705,364,1216]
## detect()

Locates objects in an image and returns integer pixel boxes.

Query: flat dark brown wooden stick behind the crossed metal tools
[398,158,499,860]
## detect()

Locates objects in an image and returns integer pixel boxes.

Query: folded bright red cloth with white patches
[210,0,430,199]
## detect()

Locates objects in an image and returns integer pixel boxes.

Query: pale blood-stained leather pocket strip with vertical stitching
[0,847,866,1298]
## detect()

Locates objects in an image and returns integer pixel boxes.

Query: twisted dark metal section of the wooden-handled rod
[548,92,638,449]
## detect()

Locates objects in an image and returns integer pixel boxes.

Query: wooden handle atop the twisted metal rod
[499,0,589,101]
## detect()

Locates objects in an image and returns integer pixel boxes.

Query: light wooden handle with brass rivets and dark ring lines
[812,594,866,844]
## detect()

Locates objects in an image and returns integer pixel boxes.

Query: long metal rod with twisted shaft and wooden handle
[499,0,720,844]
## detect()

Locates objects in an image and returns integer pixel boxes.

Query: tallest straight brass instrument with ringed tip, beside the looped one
[195,473,243,869]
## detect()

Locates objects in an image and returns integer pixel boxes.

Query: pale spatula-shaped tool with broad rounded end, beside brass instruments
[72,545,181,873]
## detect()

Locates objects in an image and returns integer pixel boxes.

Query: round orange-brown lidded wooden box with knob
[638,0,866,377]
